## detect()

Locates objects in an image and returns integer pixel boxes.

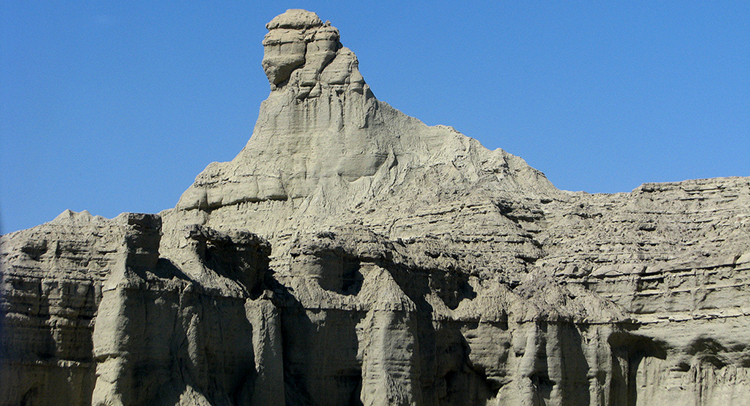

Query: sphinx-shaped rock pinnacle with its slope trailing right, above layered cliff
[177,10,556,216]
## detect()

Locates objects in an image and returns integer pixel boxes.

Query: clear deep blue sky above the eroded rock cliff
[0,0,750,233]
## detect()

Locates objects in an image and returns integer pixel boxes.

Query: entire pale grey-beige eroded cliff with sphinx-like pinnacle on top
[0,10,750,406]
